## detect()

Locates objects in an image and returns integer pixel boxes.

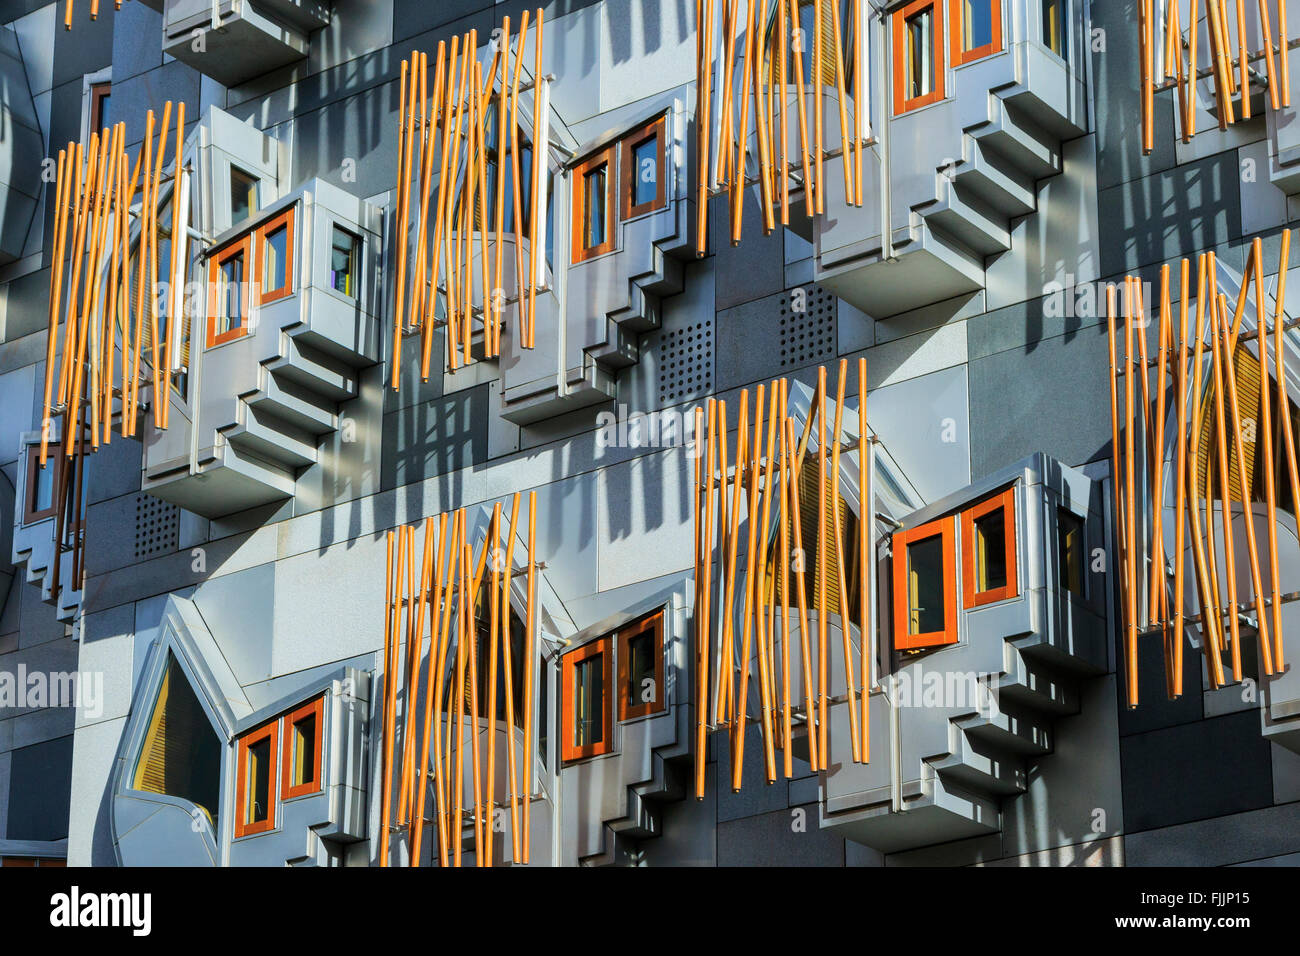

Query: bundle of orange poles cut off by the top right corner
[1138,0,1291,153]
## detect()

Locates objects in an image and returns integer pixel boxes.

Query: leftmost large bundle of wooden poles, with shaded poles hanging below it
[40,101,185,596]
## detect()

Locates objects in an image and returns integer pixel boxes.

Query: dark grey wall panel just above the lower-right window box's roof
[970,319,1110,480]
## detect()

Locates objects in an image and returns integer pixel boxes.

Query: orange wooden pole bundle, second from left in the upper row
[393,9,546,389]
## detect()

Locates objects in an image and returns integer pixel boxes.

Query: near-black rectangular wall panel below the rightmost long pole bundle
[1119,711,1273,832]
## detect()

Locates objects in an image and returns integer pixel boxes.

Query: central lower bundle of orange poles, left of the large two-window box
[694,359,875,799]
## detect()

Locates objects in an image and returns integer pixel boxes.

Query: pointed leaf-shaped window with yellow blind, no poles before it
[131,657,222,821]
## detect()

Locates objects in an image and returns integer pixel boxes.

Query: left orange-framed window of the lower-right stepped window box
[893,518,957,650]
